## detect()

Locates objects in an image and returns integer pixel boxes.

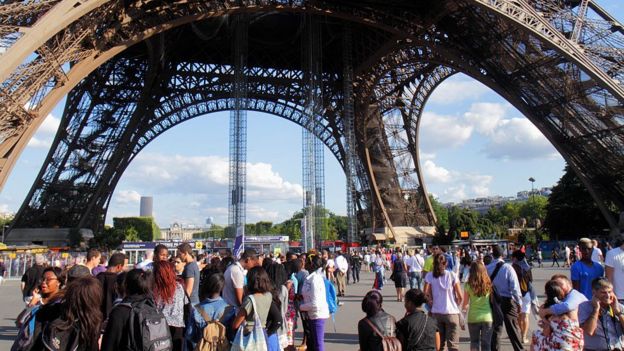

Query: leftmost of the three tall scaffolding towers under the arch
[228,14,248,257]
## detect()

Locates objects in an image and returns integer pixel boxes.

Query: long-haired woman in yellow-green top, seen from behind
[462,262,493,351]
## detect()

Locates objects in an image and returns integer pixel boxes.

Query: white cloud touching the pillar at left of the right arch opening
[420,112,473,153]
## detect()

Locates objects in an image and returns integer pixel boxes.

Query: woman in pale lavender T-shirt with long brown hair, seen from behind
[424,254,462,351]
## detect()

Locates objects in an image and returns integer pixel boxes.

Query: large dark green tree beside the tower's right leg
[544,165,617,240]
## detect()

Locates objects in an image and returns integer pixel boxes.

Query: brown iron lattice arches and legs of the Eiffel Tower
[0,0,624,242]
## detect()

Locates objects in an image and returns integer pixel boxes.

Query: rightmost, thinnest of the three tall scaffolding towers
[342,26,358,242]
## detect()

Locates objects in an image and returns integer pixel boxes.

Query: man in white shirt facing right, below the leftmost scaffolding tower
[223,249,258,307]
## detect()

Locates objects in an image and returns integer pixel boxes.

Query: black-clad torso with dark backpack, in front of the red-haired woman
[118,299,173,351]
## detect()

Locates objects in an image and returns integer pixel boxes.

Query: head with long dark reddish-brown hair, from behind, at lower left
[61,276,104,345]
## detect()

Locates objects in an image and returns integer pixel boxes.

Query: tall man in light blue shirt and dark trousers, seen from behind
[486,245,524,351]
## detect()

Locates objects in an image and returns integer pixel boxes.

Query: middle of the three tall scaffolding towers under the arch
[302,15,326,251]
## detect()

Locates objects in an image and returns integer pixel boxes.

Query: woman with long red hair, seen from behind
[153,261,189,351]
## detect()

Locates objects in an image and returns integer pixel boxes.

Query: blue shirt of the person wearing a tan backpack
[186,296,236,343]
